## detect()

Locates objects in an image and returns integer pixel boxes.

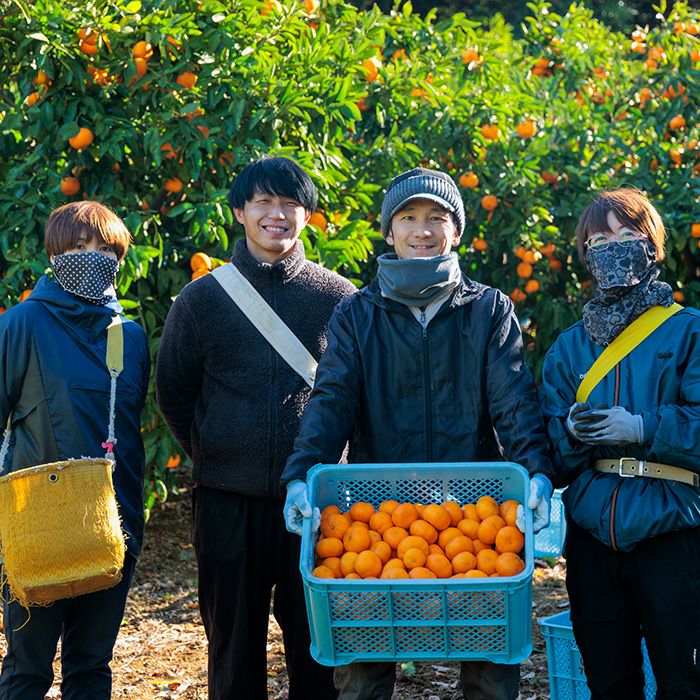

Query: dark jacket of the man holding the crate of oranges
[282,277,552,483]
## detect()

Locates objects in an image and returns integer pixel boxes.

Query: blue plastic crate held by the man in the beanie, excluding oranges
[300,462,534,666]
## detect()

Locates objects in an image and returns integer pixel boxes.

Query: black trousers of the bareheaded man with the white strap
[193,486,335,700]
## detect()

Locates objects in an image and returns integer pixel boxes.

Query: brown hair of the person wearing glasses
[576,187,666,265]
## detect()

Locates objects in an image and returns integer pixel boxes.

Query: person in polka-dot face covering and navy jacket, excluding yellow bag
[0,201,150,700]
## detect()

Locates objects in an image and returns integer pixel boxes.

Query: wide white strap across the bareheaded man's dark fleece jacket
[211,263,318,388]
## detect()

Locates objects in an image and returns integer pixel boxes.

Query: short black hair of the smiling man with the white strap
[228,157,318,212]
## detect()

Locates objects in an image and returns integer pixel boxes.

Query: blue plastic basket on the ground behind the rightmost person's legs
[539,610,656,700]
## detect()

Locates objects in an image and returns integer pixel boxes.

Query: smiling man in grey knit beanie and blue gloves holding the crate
[282,168,552,700]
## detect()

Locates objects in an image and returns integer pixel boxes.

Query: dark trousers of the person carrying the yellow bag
[0,554,136,700]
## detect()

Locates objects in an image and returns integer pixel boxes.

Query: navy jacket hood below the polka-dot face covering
[24,275,114,343]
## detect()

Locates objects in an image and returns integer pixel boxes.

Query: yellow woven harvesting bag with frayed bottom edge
[0,458,126,607]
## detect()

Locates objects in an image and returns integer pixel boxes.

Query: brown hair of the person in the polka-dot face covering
[44,202,131,260]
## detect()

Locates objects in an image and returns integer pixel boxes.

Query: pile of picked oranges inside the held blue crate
[312,496,525,579]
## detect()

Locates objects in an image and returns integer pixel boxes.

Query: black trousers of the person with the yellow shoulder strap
[565,520,700,700]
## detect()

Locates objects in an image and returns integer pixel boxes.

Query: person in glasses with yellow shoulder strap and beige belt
[542,188,700,700]
